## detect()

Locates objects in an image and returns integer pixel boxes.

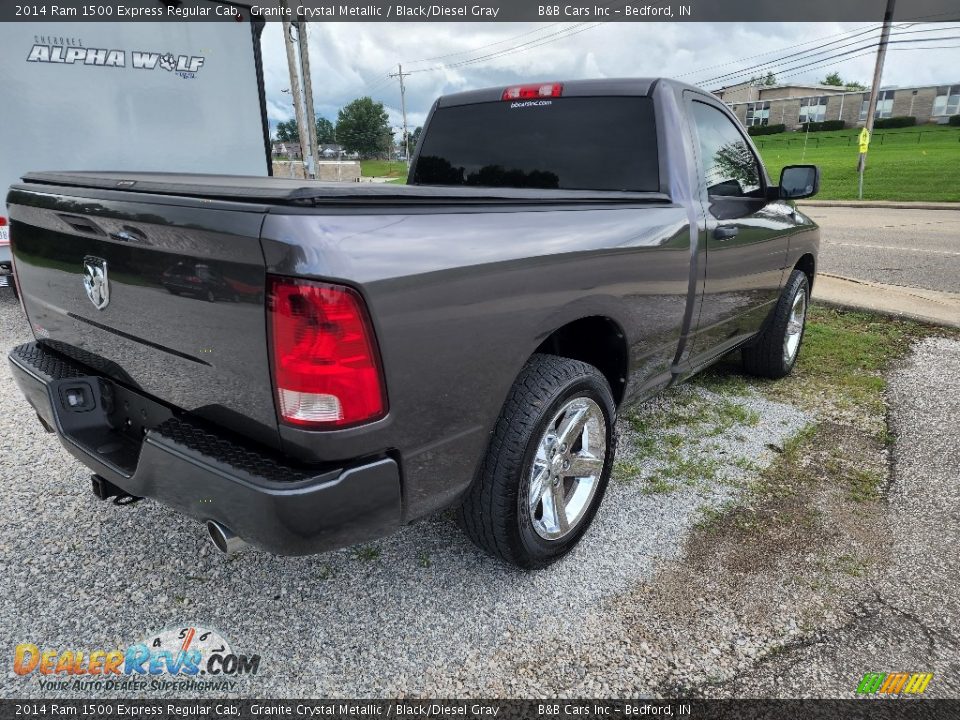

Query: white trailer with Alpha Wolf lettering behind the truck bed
[0,12,271,286]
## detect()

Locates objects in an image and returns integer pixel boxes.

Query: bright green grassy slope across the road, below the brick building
[753,125,960,202]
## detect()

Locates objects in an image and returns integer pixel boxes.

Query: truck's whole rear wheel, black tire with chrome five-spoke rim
[459,355,616,569]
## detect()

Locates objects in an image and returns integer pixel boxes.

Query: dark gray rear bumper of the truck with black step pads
[9,343,401,555]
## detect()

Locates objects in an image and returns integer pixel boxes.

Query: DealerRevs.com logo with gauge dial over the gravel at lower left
[13,626,260,691]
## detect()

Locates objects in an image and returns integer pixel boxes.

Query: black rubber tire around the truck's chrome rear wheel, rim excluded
[458,354,616,569]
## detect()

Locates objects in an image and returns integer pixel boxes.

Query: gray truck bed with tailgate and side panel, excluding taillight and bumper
[7,172,690,532]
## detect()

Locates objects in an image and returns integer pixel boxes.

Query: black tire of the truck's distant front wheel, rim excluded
[741,270,810,380]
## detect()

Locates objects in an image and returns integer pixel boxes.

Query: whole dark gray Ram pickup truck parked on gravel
[7,79,819,568]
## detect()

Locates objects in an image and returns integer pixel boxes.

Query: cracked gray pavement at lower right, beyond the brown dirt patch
[721,338,960,698]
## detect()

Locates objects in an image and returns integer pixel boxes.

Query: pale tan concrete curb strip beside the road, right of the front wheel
[813,273,960,328]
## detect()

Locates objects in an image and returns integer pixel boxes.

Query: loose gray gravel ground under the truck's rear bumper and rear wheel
[0,293,812,697]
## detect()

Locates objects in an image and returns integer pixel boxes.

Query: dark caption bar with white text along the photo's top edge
[0,0,960,23]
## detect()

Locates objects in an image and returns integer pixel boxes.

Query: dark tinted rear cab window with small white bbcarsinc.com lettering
[413,97,660,192]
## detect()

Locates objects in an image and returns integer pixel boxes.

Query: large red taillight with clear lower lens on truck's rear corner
[268,277,386,428]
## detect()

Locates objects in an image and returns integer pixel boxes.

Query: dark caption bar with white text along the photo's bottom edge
[0,698,960,720]
